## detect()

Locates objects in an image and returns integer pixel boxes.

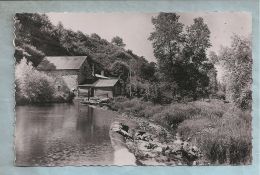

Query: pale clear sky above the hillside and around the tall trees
[47,12,252,61]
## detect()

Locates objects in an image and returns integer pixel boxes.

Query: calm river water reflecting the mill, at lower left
[15,104,116,166]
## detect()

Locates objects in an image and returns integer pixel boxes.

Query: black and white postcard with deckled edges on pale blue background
[14,11,253,166]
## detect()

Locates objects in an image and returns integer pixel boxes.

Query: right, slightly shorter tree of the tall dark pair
[182,17,212,99]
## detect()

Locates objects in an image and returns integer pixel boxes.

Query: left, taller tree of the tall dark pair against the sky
[149,13,184,81]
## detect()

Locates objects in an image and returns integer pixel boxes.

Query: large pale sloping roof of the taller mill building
[37,56,87,70]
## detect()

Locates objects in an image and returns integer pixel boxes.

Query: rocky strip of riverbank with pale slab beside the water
[110,115,205,165]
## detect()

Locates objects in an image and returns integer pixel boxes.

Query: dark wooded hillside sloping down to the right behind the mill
[15,13,155,80]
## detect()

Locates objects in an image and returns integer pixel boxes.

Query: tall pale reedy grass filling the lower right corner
[177,105,252,164]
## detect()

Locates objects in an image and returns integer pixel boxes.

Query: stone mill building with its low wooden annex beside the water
[37,56,123,98]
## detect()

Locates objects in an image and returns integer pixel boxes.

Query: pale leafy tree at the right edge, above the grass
[212,35,253,109]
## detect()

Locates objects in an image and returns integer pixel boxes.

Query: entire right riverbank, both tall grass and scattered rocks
[107,97,252,165]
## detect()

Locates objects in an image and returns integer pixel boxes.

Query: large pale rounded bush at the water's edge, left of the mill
[15,59,74,104]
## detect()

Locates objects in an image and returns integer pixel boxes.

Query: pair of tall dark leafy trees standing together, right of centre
[149,13,214,99]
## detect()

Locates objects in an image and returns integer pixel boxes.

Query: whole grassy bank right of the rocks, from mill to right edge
[111,97,252,164]
